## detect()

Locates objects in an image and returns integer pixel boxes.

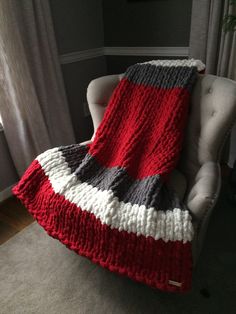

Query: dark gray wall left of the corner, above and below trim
[50,0,106,142]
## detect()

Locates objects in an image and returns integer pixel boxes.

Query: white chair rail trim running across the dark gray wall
[59,47,189,64]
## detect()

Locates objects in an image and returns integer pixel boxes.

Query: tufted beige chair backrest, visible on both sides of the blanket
[87,74,236,187]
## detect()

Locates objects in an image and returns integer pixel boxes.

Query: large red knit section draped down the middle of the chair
[89,79,190,178]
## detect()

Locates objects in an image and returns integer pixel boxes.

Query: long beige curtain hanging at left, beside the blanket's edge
[0,0,74,175]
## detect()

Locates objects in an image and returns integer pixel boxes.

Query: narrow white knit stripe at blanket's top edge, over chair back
[139,59,205,72]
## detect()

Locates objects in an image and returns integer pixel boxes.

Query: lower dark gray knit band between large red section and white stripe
[60,145,179,211]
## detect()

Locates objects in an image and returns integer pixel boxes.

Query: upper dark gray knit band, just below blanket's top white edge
[125,64,196,89]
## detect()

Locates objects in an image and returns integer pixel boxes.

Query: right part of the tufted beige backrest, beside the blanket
[179,74,236,181]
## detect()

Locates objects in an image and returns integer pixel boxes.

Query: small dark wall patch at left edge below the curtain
[0,131,19,192]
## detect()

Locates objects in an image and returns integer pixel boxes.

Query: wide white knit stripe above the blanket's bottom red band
[37,148,193,243]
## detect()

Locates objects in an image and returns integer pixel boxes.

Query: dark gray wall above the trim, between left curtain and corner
[50,0,103,54]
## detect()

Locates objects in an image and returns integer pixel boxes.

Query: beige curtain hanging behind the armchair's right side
[189,0,236,167]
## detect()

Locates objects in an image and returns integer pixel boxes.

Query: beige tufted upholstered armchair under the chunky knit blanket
[87,74,236,263]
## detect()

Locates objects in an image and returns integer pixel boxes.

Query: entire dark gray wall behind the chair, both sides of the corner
[50,0,192,141]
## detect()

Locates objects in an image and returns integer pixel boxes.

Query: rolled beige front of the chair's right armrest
[186,161,221,222]
